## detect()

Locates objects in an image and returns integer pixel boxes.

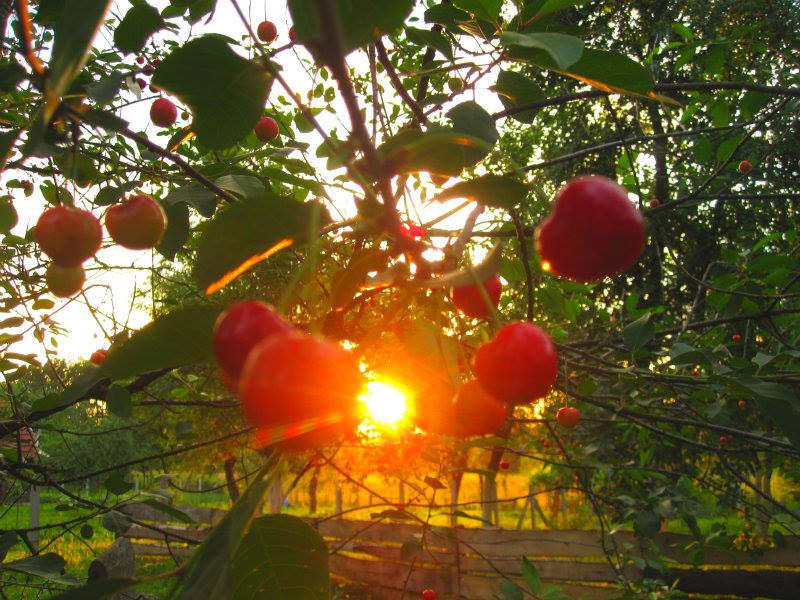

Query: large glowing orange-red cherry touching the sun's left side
[239,335,363,451]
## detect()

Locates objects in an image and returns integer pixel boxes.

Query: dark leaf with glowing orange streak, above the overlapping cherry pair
[194,193,318,293]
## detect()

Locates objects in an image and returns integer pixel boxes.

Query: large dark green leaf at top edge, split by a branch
[289,0,415,54]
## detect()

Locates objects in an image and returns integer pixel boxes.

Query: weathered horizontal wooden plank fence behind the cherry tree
[119,504,800,600]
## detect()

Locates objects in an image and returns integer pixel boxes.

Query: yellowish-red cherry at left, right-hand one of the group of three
[106,194,167,250]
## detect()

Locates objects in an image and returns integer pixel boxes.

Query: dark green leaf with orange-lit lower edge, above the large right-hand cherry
[509,46,654,96]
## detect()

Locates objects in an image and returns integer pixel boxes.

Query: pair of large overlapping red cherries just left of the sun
[213,300,363,451]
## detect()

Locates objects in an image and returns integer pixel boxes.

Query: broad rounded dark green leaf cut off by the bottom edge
[225,514,331,600]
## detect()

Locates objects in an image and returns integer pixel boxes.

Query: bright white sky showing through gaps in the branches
[0,0,502,362]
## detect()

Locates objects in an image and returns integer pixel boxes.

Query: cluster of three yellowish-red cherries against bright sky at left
[34,194,167,298]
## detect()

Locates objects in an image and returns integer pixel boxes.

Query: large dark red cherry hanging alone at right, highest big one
[536,176,645,282]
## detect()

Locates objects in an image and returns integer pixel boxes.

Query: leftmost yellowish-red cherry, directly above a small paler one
[34,206,103,267]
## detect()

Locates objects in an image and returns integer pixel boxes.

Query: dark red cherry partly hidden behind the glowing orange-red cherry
[214,300,294,382]
